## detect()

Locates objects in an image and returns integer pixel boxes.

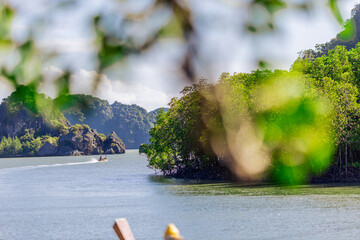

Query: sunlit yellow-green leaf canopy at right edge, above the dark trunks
[292,44,360,147]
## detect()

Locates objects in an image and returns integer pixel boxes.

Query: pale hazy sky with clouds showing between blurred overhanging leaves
[0,0,358,110]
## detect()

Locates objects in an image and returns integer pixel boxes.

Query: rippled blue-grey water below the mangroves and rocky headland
[0,150,360,240]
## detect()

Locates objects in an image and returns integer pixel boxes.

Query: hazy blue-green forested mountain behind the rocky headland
[55,94,167,149]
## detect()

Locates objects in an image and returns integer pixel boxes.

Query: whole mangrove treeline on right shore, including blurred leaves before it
[142,44,360,183]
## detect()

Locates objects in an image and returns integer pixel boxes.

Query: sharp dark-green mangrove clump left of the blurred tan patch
[142,81,224,174]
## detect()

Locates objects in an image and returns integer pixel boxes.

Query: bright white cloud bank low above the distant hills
[0,66,173,111]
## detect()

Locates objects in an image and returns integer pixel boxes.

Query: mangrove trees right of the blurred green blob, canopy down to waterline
[292,43,360,181]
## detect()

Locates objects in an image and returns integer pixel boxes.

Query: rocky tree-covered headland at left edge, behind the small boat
[0,86,125,157]
